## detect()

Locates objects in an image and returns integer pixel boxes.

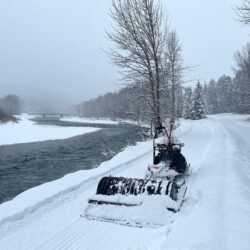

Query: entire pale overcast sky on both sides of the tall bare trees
[0,0,250,109]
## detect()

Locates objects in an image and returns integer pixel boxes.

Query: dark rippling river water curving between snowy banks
[0,121,146,203]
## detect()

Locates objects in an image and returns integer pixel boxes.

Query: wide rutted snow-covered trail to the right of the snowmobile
[164,115,250,250]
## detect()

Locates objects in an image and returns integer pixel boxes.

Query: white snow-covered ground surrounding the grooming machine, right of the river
[0,114,250,250]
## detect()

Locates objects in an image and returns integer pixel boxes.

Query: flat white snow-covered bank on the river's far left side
[0,114,98,145]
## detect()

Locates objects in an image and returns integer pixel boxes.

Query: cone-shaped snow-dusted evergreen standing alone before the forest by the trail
[188,82,206,120]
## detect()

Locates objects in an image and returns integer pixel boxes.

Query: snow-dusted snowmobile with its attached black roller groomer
[83,120,187,227]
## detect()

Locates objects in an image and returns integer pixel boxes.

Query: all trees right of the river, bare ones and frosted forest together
[75,0,250,123]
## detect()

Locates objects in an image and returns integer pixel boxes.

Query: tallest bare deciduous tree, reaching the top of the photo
[108,0,167,123]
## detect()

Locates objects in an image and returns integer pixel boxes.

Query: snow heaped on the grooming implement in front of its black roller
[85,195,175,227]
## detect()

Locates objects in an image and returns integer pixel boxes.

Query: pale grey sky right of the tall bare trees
[164,0,250,82]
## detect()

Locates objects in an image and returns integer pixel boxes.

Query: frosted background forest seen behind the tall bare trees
[75,37,250,121]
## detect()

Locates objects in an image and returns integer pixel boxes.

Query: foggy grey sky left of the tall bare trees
[0,0,117,111]
